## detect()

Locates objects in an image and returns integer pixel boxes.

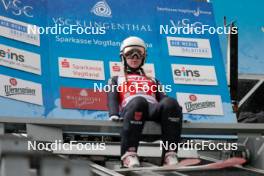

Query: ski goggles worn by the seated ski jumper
[123,46,145,59]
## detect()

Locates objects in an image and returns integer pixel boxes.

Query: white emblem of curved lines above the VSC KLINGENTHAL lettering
[91,0,112,17]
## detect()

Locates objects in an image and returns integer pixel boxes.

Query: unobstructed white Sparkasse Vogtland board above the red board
[59,57,105,80]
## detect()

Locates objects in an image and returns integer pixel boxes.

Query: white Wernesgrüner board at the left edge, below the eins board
[0,74,43,105]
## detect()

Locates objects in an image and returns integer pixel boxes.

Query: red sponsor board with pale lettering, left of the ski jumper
[60,87,108,111]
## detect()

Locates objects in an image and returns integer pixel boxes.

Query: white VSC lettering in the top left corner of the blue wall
[1,0,34,18]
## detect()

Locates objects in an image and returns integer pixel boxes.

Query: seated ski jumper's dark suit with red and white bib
[108,72,182,162]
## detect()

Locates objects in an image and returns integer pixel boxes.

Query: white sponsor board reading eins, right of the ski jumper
[171,64,218,85]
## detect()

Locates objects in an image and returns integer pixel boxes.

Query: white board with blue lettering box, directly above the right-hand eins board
[167,37,212,58]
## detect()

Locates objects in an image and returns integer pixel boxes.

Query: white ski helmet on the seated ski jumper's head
[120,36,147,67]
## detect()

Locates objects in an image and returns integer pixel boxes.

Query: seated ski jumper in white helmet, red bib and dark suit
[108,37,182,168]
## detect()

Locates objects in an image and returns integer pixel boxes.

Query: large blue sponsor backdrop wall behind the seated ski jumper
[0,0,236,123]
